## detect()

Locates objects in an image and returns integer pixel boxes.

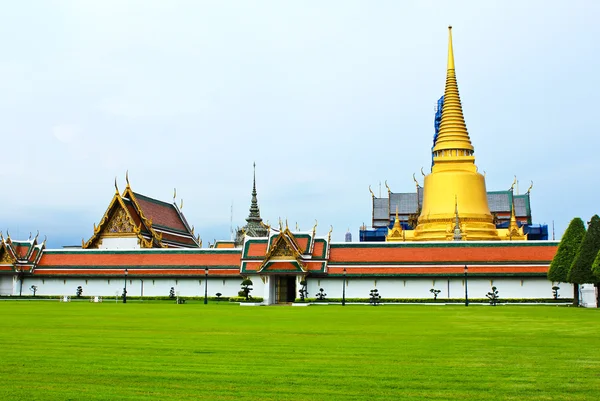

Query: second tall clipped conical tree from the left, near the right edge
[567,214,600,306]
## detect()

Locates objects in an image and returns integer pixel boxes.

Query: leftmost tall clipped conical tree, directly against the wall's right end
[548,217,585,283]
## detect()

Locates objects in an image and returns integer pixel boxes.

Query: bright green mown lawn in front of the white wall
[0,301,600,400]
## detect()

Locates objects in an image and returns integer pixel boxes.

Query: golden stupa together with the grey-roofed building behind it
[361,27,547,241]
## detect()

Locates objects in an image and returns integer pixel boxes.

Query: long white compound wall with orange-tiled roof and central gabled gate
[0,229,572,304]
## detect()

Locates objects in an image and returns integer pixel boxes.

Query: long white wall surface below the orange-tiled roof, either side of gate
[10,276,573,299]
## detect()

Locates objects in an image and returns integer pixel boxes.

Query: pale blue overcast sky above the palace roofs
[0,0,600,247]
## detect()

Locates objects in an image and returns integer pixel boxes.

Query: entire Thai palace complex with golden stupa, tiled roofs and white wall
[0,28,571,304]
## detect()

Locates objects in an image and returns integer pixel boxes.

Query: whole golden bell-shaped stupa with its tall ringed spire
[414,27,500,241]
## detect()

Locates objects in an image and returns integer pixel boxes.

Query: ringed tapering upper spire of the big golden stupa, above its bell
[433,26,474,162]
